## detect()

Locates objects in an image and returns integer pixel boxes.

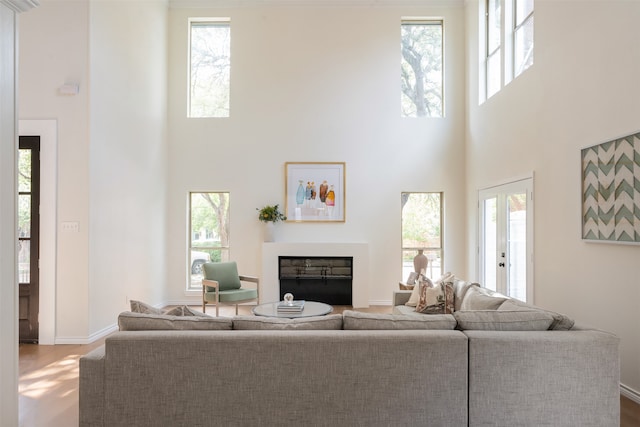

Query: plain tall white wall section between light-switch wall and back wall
[89,1,167,338]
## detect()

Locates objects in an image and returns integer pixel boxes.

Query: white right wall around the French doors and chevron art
[467,1,640,391]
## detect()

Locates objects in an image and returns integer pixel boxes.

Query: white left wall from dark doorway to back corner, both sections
[19,0,167,343]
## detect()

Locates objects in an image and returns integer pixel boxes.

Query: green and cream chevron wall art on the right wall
[582,132,640,243]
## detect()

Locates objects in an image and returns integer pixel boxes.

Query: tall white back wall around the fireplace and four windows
[168,2,466,304]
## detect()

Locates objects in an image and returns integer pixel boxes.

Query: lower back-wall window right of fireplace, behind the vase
[401,193,444,279]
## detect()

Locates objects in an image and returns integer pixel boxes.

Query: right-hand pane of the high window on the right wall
[513,0,533,77]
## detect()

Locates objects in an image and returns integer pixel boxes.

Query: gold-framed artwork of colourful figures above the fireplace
[285,162,346,222]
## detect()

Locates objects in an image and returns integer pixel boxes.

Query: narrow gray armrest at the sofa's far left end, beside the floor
[79,345,105,427]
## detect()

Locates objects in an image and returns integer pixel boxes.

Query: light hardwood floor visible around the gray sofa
[16,306,640,427]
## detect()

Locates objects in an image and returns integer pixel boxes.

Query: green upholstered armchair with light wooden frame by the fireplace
[202,261,260,316]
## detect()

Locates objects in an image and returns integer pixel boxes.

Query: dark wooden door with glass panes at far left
[18,136,40,343]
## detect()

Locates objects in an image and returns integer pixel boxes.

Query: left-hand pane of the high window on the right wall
[486,0,502,98]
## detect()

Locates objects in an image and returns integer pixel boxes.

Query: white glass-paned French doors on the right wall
[478,178,533,303]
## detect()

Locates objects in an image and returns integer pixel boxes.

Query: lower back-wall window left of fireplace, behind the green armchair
[187,193,229,290]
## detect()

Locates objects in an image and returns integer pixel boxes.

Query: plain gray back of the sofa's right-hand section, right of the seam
[464,330,620,427]
